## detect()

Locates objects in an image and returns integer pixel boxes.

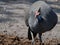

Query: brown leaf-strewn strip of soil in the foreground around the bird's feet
[0,34,59,45]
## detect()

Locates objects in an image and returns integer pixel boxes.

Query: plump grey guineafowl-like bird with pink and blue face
[25,1,58,45]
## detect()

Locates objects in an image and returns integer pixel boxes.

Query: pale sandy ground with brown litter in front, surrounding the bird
[0,2,60,45]
